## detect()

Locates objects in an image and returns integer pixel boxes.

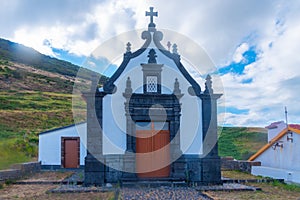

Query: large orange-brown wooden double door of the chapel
[136,122,170,178]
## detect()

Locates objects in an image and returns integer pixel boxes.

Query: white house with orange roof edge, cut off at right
[249,121,300,183]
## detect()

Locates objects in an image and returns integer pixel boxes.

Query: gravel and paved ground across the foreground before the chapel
[4,171,300,200]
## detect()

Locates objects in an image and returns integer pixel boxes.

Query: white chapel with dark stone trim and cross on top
[84,7,221,186]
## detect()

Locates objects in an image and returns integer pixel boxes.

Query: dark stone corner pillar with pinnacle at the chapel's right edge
[200,75,222,184]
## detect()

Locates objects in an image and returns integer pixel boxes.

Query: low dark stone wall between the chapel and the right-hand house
[221,157,261,173]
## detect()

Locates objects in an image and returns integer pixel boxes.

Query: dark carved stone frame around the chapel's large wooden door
[123,90,185,179]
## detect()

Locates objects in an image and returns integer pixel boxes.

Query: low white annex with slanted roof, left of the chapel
[38,123,87,169]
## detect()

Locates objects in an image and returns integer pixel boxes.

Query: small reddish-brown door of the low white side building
[64,139,79,168]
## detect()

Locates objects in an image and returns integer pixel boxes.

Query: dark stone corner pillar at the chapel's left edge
[84,74,105,186]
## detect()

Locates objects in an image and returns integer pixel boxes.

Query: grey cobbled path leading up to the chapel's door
[120,187,211,200]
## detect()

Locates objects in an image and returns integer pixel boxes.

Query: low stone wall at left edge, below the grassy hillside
[0,162,41,181]
